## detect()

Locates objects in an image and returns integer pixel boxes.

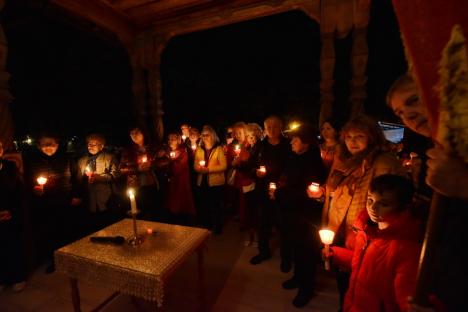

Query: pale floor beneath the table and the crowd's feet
[0,222,338,312]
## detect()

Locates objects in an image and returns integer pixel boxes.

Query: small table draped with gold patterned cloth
[55,219,210,312]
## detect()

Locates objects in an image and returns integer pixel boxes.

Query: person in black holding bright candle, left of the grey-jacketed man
[24,131,81,273]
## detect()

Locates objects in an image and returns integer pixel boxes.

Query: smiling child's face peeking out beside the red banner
[390,83,431,137]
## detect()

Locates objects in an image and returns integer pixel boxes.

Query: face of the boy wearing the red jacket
[366,191,401,223]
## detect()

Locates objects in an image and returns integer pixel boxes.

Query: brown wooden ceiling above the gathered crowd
[50,0,320,44]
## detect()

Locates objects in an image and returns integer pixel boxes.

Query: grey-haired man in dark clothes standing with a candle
[250,115,291,266]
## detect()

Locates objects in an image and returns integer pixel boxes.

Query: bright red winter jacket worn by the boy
[333,211,423,312]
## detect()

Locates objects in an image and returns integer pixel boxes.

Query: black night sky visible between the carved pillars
[1,0,405,142]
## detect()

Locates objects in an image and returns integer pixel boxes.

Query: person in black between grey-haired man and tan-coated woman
[270,124,326,307]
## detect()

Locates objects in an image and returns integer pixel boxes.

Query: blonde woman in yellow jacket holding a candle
[194,126,227,234]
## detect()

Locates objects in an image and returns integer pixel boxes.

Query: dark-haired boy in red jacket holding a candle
[324,174,423,311]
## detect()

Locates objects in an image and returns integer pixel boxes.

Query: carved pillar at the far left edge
[0,0,13,150]
